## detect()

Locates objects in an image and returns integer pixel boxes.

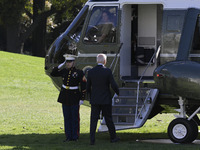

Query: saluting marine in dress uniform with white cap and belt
[51,54,86,142]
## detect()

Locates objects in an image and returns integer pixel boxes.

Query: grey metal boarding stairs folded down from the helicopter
[98,87,158,132]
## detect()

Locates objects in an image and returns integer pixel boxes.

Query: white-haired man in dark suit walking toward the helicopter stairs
[87,54,119,145]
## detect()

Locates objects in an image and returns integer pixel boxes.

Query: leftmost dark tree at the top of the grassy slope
[0,0,26,52]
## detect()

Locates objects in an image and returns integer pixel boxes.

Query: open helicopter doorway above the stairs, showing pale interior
[120,4,163,80]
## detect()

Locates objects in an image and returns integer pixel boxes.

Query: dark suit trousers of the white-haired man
[90,104,116,142]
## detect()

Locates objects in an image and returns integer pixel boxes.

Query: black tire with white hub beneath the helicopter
[168,118,198,143]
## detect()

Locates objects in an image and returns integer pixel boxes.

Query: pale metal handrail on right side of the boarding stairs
[135,45,161,120]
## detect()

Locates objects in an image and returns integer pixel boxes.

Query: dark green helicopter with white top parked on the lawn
[45,0,200,143]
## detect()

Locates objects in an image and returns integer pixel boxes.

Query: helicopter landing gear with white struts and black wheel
[168,97,200,143]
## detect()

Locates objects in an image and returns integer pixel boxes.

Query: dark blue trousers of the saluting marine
[62,104,80,140]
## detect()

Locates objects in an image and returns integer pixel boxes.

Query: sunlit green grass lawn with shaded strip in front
[0,51,200,150]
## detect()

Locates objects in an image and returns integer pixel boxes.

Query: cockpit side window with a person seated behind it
[84,6,118,44]
